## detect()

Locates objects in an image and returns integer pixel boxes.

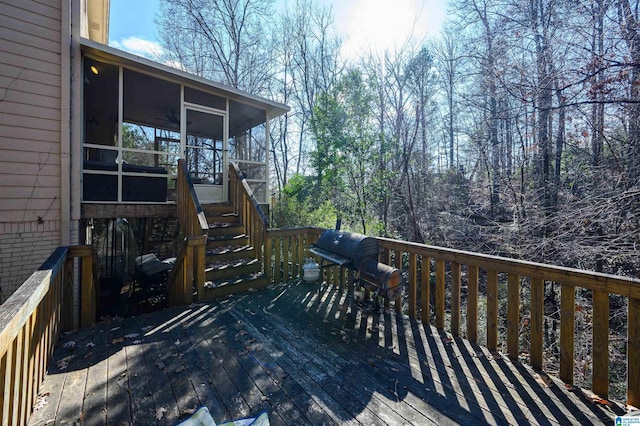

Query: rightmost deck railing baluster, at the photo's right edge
[627,297,640,407]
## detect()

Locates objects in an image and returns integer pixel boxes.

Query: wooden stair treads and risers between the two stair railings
[202,203,268,299]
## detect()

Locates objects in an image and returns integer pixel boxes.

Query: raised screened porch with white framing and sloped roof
[82,40,287,204]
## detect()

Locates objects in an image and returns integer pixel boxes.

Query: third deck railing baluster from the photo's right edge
[560,284,576,385]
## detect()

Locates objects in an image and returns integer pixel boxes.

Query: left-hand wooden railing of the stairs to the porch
[167,159,209,306]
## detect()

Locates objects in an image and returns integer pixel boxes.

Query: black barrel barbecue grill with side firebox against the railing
[309,229,402,300]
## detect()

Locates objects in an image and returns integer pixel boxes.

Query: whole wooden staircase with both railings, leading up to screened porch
[167,159,271,306]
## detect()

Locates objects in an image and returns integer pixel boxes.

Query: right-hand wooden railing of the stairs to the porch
[229,163,269,272]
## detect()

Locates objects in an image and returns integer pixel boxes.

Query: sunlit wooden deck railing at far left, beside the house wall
[0,246,99,425]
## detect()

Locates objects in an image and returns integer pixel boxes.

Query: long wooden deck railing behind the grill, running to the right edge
[266,228,640,407]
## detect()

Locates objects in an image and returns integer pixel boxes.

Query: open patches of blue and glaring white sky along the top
[109,0,446,57]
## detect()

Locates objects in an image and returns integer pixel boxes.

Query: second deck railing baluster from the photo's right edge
[592,290,609,399]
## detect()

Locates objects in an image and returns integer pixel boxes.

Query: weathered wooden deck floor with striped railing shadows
[30,281,624,425]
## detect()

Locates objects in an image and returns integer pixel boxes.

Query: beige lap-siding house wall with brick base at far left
[0,0,64,300]
